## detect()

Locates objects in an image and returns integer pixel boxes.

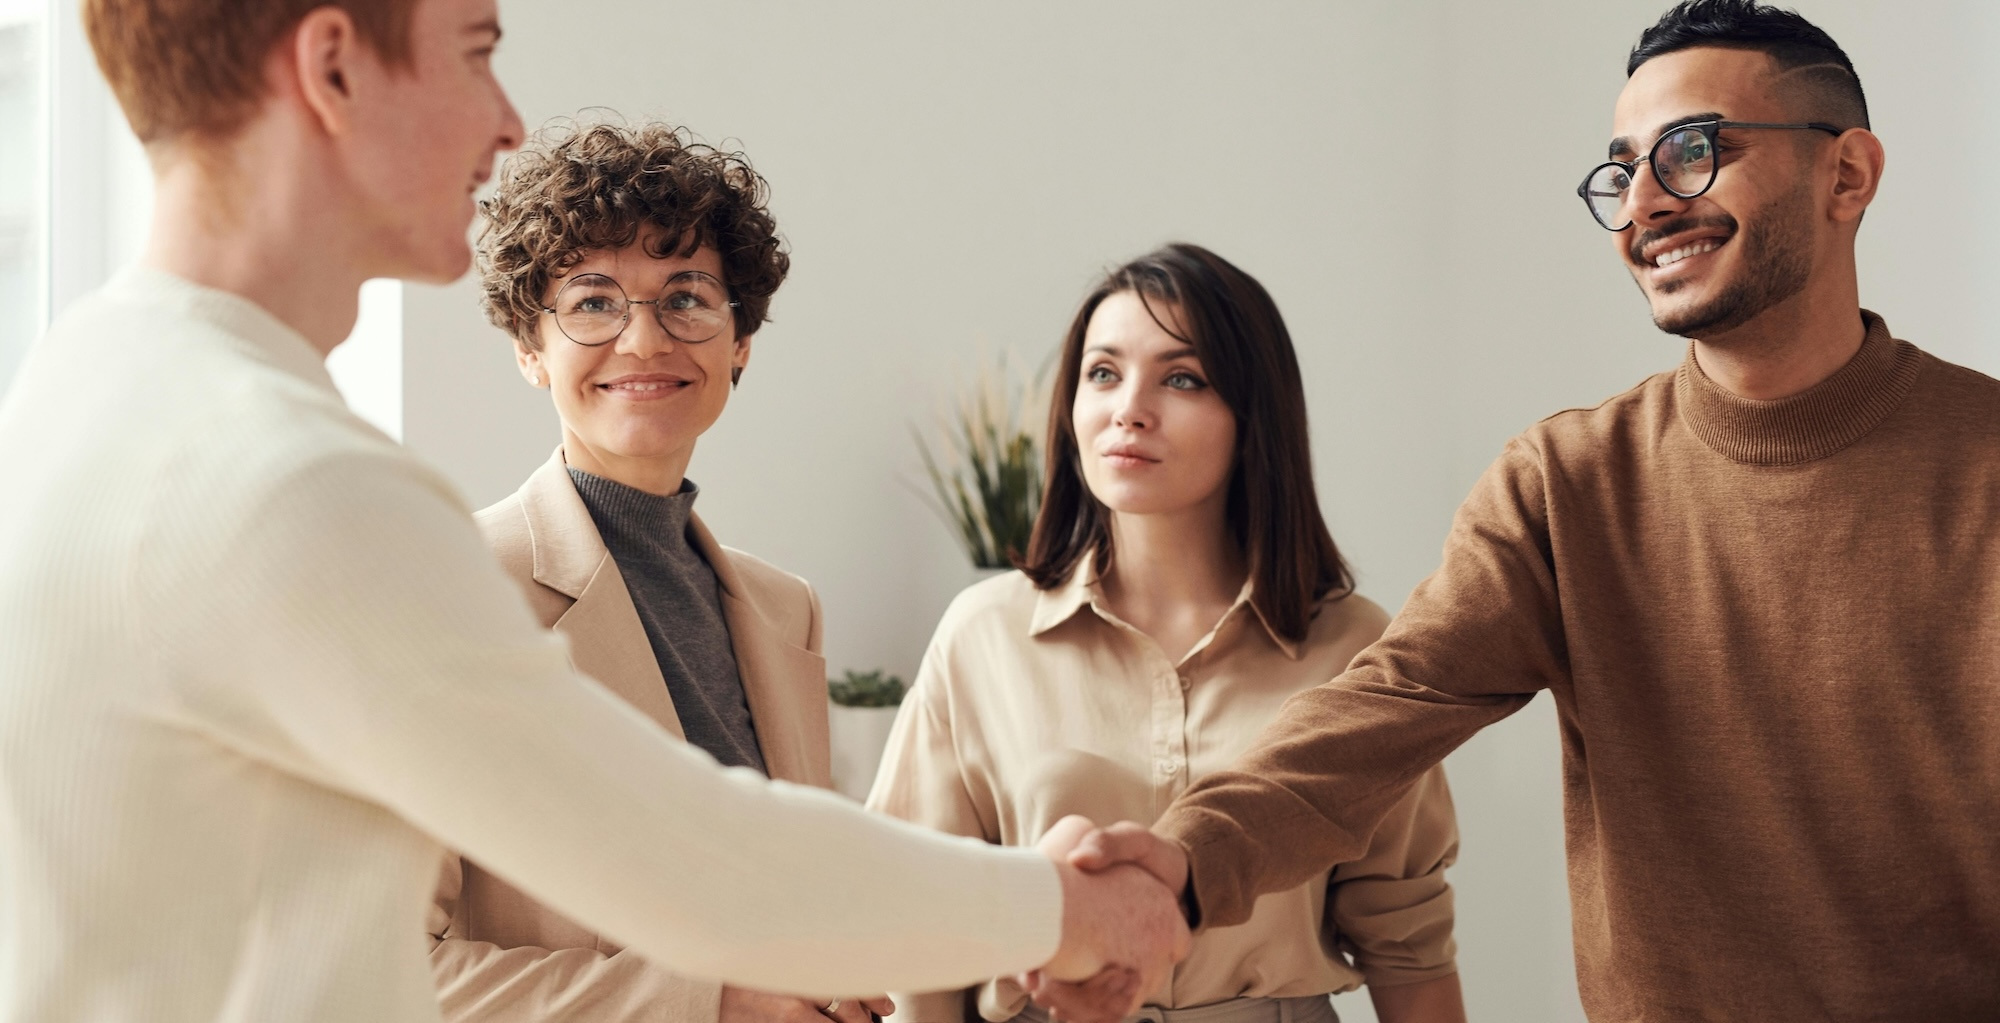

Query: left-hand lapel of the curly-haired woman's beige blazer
[522,448,684,737]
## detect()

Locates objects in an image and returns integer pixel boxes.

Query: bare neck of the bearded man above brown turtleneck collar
[1694,282,1868,402]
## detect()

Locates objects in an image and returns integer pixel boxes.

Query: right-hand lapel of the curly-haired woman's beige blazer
[688,515,834,789]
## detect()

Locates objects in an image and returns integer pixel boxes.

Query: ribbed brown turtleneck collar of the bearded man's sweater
[1674,310,1918,466]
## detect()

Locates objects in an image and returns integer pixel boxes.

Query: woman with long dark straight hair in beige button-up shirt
[868,244,1464,1023]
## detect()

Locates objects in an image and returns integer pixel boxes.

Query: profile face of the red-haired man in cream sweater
[354,0,524,284]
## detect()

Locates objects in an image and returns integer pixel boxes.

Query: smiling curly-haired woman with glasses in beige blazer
[428,124,890,1023]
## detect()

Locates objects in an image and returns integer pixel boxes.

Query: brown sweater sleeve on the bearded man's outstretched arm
[1156,438,1568,927]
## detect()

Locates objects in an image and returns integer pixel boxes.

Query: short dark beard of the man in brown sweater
[1632,180,1812,338]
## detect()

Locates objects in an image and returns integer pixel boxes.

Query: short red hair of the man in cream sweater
[84,0,418,146]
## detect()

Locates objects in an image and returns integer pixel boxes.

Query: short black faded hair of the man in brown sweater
[1626,0,1868,128]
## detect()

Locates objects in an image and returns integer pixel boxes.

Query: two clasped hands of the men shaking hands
[1020,815,1190,1023]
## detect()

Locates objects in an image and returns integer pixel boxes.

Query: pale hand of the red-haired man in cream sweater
[1020,817,1188,1023]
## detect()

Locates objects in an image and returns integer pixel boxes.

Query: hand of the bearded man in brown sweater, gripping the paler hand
[1020,817,1188,1023]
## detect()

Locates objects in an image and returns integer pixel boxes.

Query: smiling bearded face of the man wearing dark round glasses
[1610,46,1830,338]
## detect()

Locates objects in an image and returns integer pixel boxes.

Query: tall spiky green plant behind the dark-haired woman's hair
[916,360,1042,573]
